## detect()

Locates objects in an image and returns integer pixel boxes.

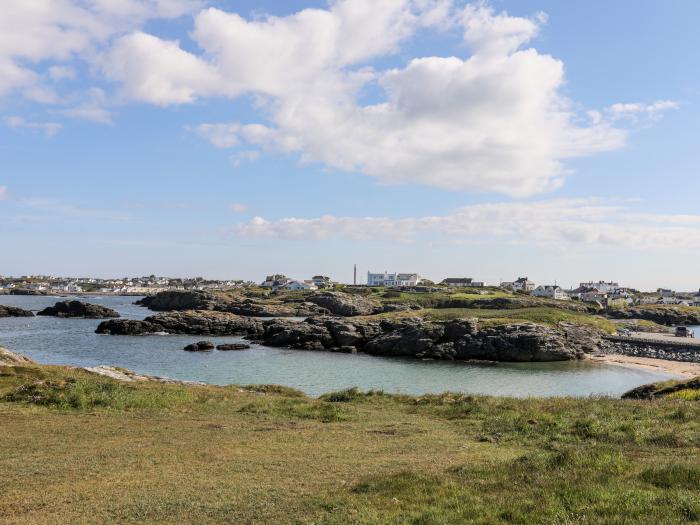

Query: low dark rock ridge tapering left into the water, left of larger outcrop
[95,311,262,336]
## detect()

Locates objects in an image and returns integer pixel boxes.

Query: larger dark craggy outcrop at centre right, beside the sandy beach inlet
[252,318,598,362]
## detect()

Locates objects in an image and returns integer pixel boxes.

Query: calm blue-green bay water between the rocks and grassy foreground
[0,295,672,396]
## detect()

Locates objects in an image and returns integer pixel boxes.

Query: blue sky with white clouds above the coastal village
[0,0,700,290]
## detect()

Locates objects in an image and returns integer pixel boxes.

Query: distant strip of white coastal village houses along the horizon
[0,271,700,308]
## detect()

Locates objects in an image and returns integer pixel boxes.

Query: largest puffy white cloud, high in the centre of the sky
[105,0,662,196]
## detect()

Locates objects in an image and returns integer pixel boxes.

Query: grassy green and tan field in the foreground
[0,366,700,524]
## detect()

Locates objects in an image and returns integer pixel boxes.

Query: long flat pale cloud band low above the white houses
[236,199,700,250]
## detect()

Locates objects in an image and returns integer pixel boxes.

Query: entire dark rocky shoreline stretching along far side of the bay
[96,311,600,362]
